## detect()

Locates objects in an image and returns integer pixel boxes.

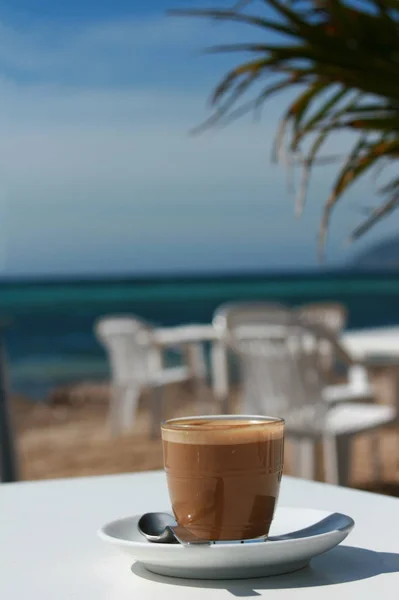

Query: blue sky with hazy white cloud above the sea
[0,0,397,275]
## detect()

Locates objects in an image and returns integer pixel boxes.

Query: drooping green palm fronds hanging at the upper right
[172,0,399,251]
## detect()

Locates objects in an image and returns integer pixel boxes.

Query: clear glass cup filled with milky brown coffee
[162,415,284,541]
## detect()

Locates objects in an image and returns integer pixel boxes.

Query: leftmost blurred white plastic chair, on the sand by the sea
[95,316,204,437]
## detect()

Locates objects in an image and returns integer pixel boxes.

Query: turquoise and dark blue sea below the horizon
[0,271,399,399]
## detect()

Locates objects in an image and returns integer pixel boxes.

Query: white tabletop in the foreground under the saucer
[0,472,399,600]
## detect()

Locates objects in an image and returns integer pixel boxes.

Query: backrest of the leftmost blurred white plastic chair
[95,315,159,385]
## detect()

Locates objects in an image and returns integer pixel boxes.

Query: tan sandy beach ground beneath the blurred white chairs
[12,377,399,496]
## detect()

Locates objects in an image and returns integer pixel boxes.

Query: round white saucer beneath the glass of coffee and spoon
[98,507,354,579]
